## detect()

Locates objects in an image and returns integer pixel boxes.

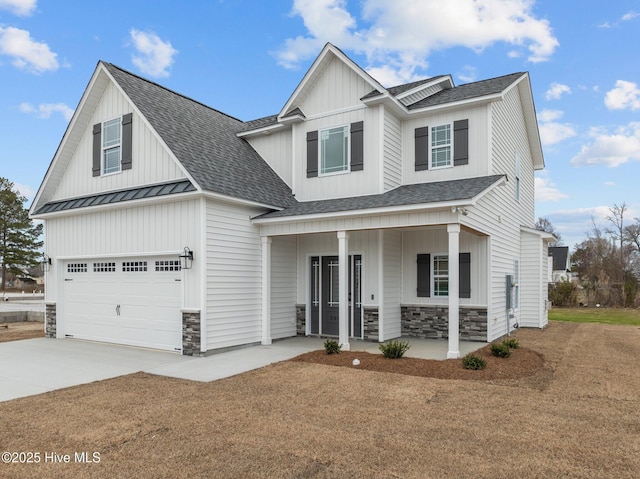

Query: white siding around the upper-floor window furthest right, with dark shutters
[402,106,490,184]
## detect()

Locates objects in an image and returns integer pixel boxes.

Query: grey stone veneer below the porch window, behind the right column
[400,305,487,341]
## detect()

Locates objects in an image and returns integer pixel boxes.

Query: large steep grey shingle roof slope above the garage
[103,63,295,207]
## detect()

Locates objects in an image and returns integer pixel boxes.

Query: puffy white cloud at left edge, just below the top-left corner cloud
[0,27,58,73]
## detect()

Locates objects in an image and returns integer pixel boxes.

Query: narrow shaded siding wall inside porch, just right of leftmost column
[271,236,304,339]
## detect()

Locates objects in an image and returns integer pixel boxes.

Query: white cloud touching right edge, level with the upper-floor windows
[571,122,640,168]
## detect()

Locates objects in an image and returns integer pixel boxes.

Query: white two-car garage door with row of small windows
[62,256,182,351]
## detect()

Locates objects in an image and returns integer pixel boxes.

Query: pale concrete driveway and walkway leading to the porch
[0,338,322,401]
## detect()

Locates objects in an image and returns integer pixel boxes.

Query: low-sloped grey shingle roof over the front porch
[259,175,504,219]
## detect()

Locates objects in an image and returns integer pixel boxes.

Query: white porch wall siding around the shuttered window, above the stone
[402,227,488,306]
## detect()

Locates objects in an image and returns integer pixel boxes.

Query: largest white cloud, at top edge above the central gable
[276,0,559,81]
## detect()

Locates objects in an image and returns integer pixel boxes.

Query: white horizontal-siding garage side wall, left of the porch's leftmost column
[206,200,264,350]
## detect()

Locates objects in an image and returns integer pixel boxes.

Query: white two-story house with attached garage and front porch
[31,44,554,357]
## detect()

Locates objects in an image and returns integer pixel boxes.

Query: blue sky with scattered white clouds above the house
[0,0,640,247]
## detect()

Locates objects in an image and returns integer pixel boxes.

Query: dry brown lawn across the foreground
[0,323,640,479]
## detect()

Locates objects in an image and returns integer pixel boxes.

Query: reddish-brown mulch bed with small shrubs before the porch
[291,345,544,380]
